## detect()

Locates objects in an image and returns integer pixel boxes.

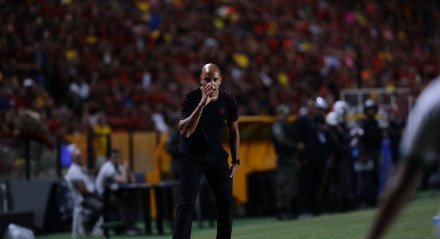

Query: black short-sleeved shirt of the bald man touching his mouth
[180,88,238,161]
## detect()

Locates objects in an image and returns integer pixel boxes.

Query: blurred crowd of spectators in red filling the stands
[0,0,440,137]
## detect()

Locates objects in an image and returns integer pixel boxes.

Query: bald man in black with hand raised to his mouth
[173,64,240,239]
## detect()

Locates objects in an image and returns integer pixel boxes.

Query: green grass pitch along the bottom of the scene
[38,191,440,239]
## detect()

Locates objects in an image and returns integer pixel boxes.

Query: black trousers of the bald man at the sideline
[173,155,233,239]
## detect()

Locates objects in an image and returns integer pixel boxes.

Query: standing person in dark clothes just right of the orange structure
[271,105,298,220]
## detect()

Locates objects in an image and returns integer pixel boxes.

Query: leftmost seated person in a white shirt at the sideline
[64,145,103,234]
